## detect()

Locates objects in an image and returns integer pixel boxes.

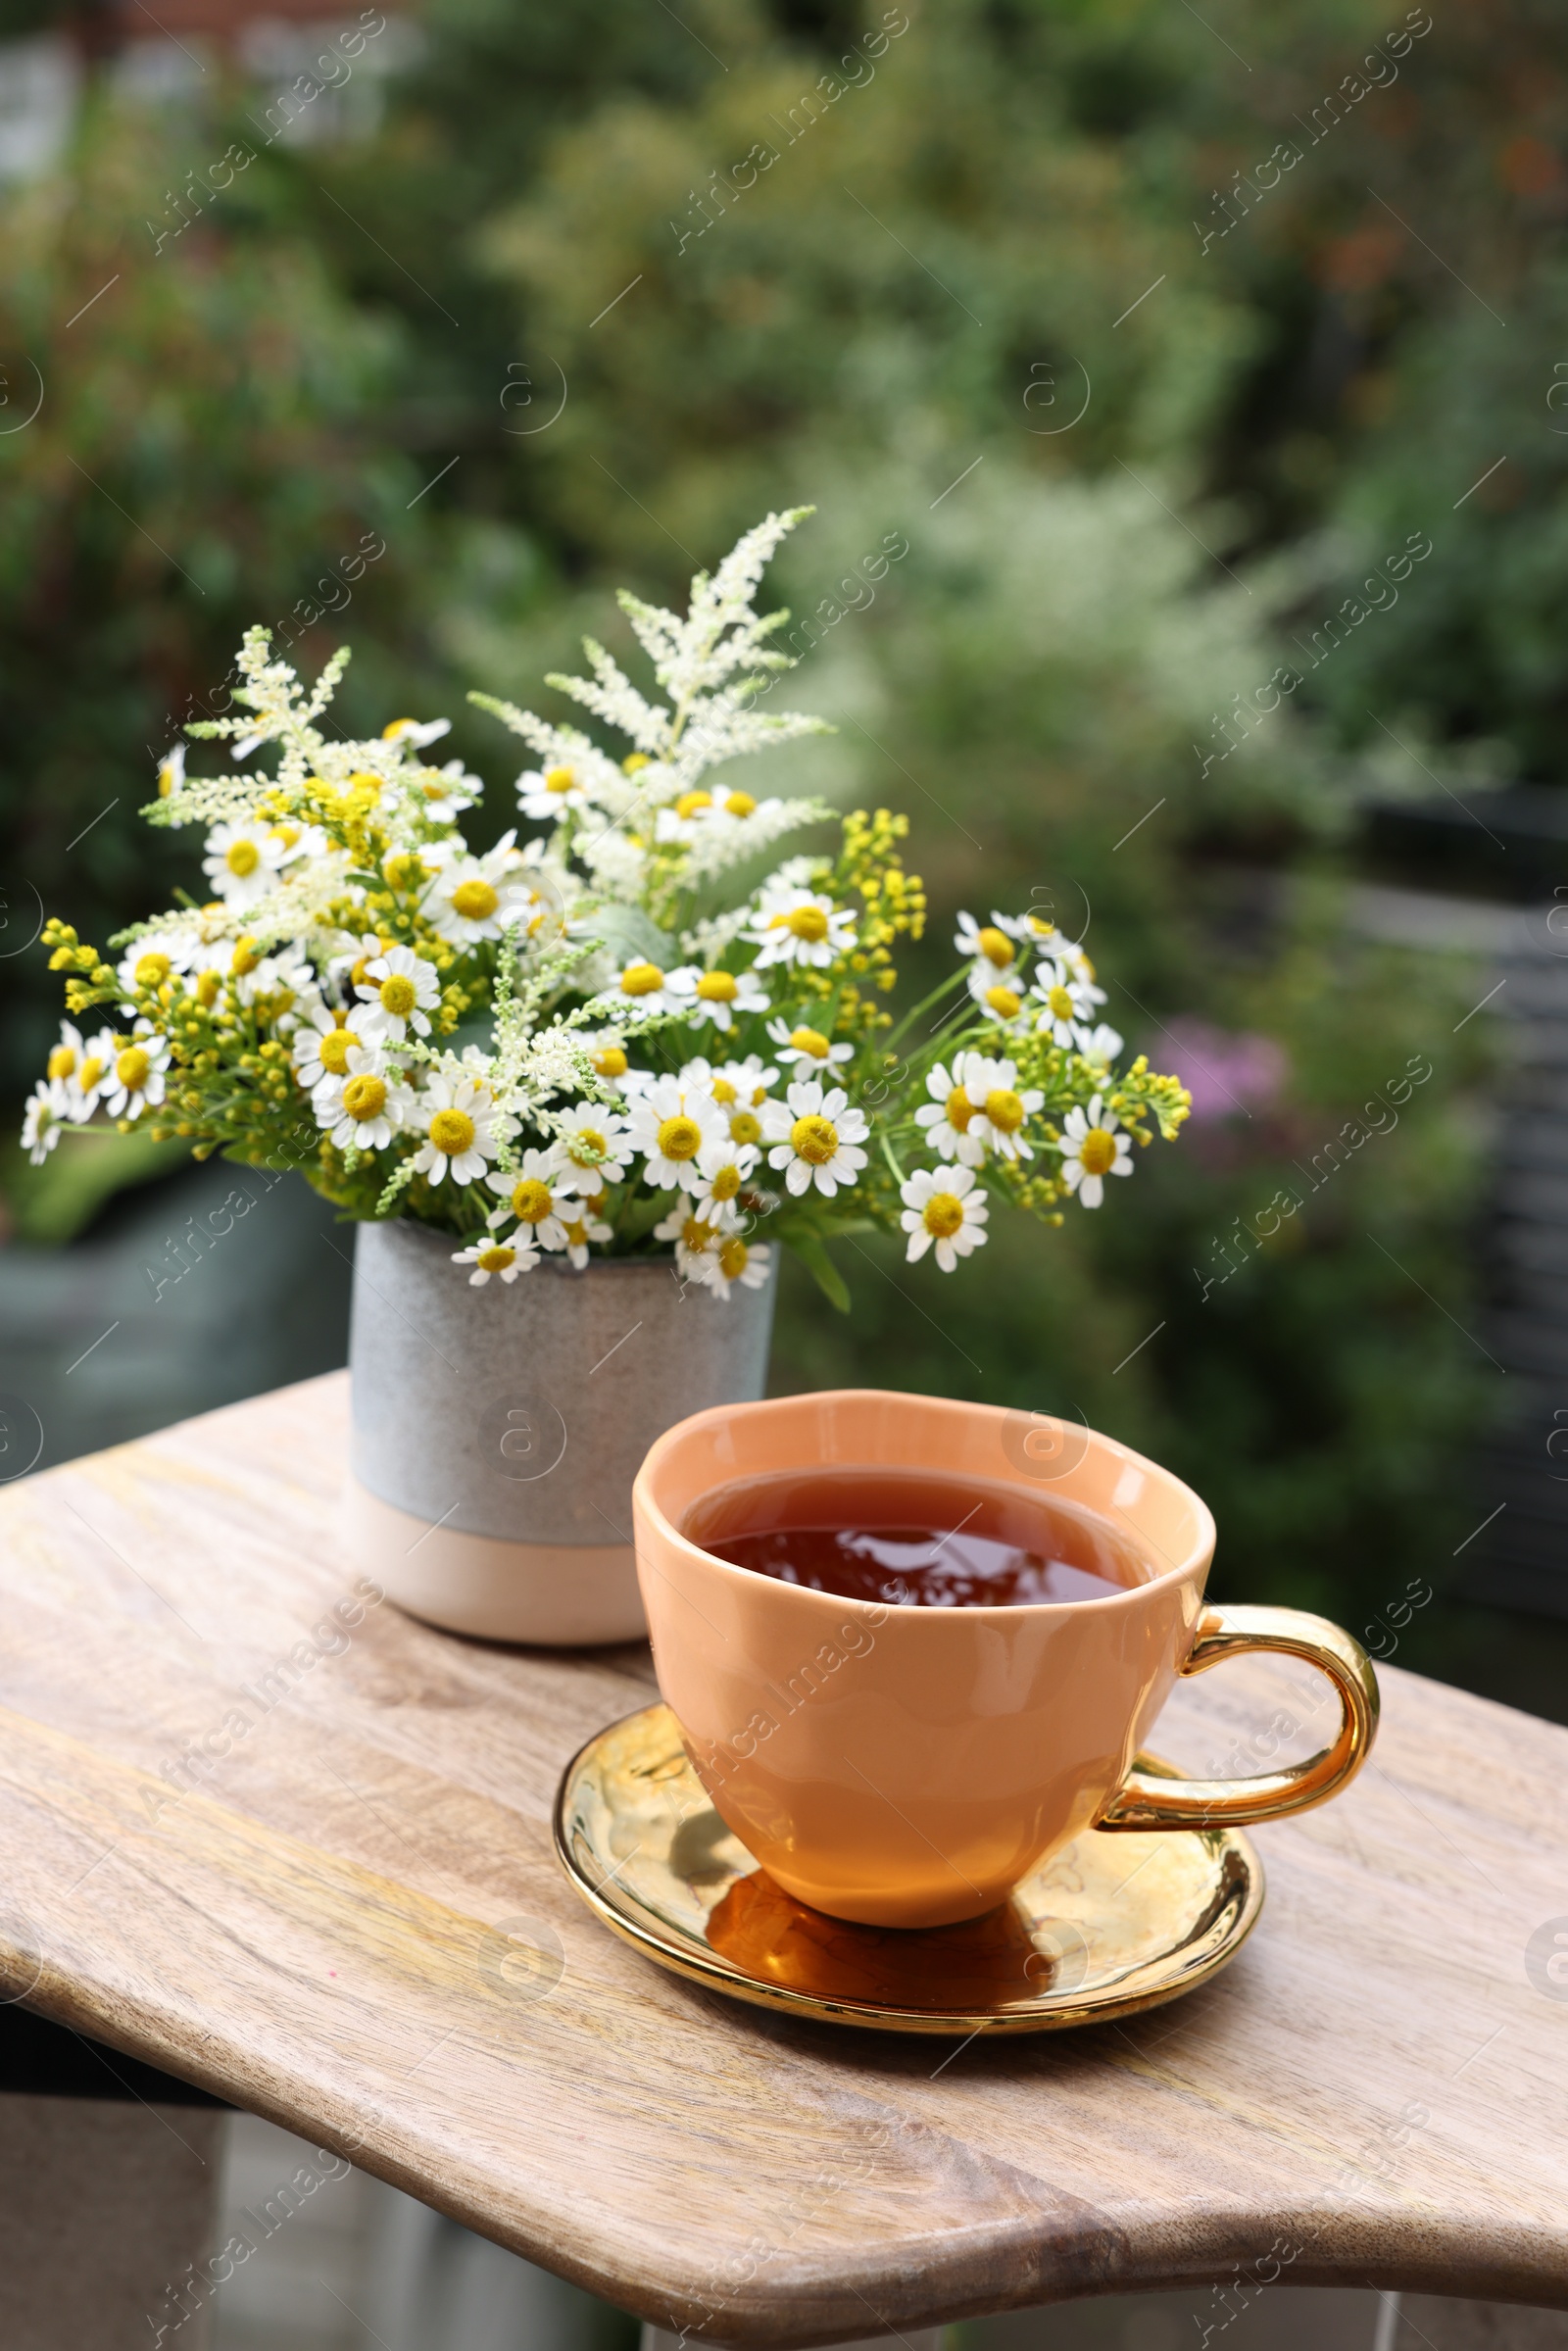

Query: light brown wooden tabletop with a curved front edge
[0,1375,1568,2344]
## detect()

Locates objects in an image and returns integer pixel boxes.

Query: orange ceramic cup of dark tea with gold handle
[632,1390,1378,1928]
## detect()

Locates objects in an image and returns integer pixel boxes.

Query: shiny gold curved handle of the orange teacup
[1101,1608,1378,1829]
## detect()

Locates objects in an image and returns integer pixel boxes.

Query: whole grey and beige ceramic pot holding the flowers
[346,1222,778,1645]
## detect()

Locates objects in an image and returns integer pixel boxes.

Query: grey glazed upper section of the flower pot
[350,1222,778,1543]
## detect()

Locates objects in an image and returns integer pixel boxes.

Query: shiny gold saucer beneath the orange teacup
[555,1707,1262,2033]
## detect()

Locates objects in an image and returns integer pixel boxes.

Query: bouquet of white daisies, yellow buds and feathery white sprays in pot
[24,508,1187,1304]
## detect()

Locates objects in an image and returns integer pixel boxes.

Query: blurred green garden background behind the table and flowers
[0,0,1568,1716]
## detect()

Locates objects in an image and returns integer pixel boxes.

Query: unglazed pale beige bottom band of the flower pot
[343,1474,647,1648]
